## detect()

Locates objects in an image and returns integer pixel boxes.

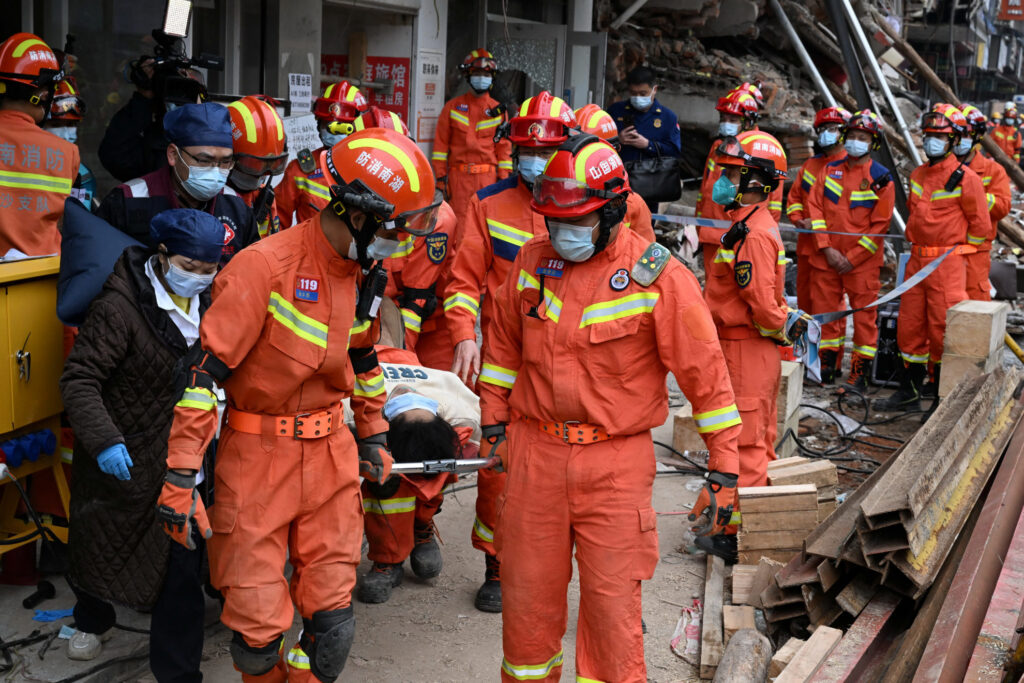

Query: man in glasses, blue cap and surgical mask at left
[96,102,259,265]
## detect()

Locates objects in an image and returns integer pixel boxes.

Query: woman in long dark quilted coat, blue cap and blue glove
[60,209,224,681]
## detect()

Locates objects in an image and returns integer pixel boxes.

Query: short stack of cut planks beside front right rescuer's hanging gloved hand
[736,483,818,564]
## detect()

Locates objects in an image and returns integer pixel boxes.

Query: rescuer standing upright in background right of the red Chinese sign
[430,48,512,227]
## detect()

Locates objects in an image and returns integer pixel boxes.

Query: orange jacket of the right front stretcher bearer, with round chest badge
[477,229,740,473]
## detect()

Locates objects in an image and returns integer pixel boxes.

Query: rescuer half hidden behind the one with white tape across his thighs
[953,104,1011,301]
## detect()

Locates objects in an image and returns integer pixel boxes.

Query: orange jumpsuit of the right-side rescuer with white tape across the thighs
[896,155,992,364]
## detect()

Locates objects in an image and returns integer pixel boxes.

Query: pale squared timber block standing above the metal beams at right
[939,300,1010,398]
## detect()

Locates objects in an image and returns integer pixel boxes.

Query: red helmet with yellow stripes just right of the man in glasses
[227,95,288,176]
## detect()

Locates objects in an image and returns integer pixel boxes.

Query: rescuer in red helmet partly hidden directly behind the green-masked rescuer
[696,83,782,274]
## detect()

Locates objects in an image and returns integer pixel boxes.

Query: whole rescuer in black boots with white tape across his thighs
[874,104,992,411]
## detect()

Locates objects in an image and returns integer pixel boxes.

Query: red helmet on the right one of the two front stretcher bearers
[529,134,629,218]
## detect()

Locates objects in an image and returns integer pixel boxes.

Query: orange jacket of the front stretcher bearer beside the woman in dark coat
[167,214,387,469]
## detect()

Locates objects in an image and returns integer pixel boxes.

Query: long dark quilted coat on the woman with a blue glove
[60,247,209,608]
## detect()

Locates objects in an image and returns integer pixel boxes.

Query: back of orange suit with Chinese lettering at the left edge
[0,111,79,256]
